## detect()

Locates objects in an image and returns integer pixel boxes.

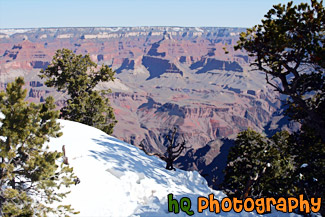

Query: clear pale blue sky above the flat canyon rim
[0,0,310,28]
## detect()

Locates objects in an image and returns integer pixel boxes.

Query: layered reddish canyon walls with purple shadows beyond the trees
[0,27,292,184]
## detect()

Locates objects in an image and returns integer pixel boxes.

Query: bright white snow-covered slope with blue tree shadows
[50,120,298,217]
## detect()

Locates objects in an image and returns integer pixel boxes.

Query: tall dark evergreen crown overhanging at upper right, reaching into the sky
[235,0,325,141]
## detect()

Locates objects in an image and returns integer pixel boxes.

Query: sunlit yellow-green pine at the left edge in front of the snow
[0,77,78,216]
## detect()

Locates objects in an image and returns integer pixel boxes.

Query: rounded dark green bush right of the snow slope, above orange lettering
[223,129,294,198]
